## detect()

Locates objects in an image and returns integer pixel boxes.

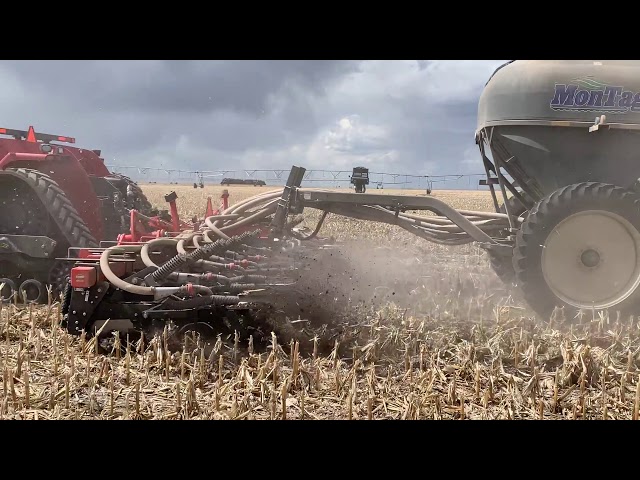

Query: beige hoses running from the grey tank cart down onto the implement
[95,188,522,318]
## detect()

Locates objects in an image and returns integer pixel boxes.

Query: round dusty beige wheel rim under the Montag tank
[542,210,640,309]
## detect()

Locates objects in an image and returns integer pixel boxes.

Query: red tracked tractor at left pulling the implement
[0,127,162,301]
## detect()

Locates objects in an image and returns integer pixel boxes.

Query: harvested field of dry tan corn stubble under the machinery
[0,185,640,419]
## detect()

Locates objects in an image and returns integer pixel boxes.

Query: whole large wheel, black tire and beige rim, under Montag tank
[513,182,640,320]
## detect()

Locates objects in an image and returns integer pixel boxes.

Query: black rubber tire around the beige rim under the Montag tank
[513,182,640,320]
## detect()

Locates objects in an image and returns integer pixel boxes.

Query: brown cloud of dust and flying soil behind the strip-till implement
[250,238,509,354]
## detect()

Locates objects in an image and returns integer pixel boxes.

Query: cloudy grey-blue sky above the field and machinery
[0,60,505,186]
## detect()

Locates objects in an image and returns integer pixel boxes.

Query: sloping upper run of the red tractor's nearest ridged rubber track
[0,168,99,248]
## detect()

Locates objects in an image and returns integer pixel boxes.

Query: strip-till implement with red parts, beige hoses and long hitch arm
[40,166,508,348]
